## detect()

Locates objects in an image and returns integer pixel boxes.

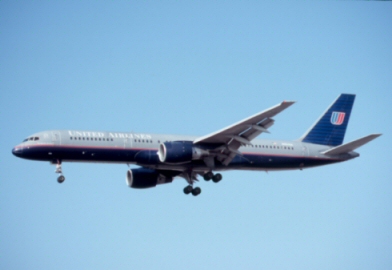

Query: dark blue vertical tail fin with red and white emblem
[301,94,355,146]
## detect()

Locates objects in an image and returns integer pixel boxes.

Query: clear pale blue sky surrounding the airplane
[0,0,392,269]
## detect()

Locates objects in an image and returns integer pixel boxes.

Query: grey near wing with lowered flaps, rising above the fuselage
[193,101,294,165]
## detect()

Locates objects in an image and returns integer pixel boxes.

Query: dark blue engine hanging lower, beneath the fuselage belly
[126,168,173,188]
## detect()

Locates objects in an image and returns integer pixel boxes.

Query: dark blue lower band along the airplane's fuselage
[21,145,344,170]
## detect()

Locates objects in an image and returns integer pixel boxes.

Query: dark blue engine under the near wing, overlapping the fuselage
[158,141,208,164]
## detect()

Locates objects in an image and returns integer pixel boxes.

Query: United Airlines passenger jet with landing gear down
[12,94,382,196]
